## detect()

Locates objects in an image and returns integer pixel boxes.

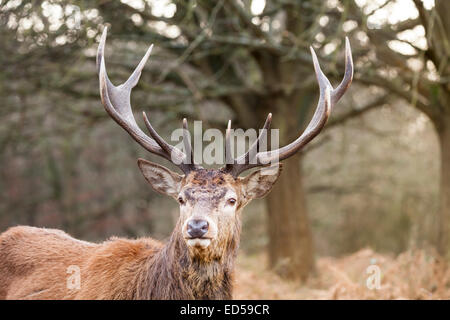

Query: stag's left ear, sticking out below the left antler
[138,159,183,198]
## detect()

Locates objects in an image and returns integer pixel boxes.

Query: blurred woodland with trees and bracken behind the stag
[0,0,450,298]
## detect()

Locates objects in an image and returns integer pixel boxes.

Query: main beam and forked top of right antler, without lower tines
[224,38,353,177]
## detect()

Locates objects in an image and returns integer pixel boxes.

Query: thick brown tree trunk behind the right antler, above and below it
[265,92,314,280]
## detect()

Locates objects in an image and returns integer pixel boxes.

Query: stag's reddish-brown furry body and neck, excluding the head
[0,222,237,299]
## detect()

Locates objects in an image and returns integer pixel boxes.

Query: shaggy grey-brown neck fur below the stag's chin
[135,223,239,300]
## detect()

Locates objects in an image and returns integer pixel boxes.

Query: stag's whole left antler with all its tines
[97,27,197,174]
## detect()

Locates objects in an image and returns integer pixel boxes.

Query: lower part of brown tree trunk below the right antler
[267,155,314,280]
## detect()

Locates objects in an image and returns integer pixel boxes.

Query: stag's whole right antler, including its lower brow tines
[224,37,353,177]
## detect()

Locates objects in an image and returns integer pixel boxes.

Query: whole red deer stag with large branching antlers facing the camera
[0,29,353,299]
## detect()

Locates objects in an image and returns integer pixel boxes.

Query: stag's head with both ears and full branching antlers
[97,28,353,258]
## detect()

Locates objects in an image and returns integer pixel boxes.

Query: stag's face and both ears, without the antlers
[138,159,280,258]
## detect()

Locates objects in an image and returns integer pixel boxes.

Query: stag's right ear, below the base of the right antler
[241,163,281,200]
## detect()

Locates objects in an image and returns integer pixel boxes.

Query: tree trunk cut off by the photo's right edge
[437,116,450,256]
